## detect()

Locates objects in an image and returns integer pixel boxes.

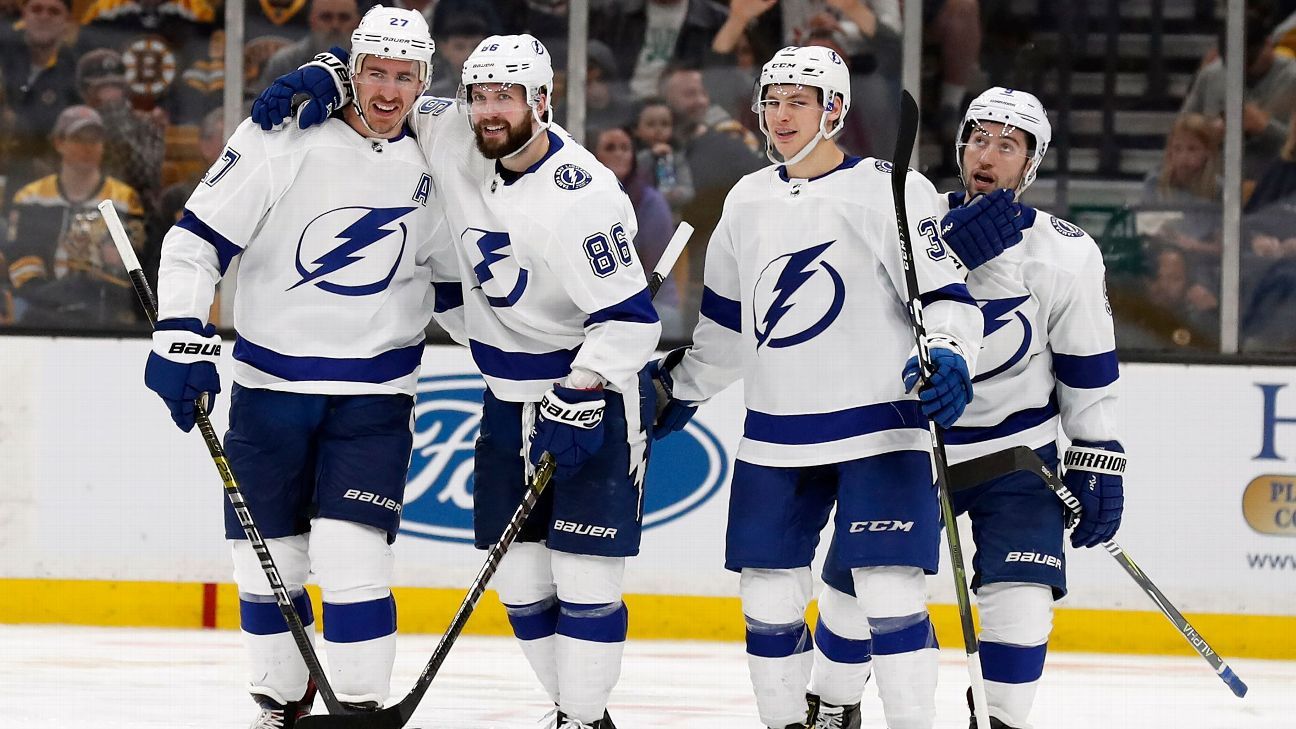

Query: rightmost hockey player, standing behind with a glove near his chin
[811,88,1124,729]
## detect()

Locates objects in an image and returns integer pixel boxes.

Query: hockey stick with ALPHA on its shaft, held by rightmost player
[950,445,1247,698]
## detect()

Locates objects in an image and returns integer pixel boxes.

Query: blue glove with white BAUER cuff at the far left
[144,319,220,433]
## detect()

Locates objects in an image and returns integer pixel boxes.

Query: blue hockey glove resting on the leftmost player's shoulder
[251,45,350,131]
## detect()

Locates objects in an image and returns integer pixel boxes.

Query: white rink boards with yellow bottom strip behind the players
[0,337,1296,659]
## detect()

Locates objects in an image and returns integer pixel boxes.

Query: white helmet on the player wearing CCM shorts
[752,45,850,165]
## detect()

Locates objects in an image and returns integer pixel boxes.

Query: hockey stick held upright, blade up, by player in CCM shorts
[892,91,990,729]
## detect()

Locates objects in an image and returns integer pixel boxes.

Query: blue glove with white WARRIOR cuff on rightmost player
[1061,441,1125,547]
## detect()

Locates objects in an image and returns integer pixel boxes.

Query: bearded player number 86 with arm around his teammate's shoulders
[254,35,661,729]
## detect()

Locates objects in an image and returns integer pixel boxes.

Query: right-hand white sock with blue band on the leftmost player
[324,594,397,704]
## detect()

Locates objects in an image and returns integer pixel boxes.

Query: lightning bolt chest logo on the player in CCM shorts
[752,240,846,349]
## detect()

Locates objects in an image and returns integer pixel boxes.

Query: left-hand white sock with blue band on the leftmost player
[238,588,315,704]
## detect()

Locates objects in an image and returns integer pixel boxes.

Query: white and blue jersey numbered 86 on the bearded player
[401,97,661,402]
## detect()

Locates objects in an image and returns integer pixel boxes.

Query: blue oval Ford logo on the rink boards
[400,374,730,542]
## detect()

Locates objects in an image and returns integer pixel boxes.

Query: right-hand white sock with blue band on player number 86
[555,601,629,724]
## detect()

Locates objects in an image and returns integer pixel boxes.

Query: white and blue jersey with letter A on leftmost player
[158,118,459,394]
